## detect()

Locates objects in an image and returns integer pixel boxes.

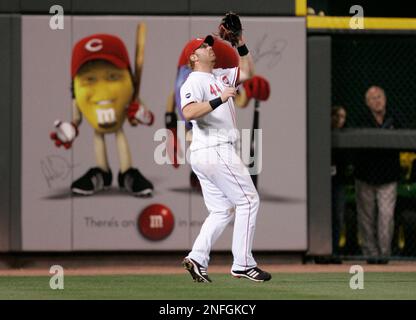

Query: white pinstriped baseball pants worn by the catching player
[188,144,259,271]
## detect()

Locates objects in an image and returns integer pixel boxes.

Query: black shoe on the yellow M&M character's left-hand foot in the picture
[71,167,113,196]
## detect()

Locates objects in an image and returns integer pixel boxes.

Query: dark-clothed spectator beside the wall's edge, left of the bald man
[331,106,347,263]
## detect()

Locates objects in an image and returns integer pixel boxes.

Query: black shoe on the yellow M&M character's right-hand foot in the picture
[118,168,153,197]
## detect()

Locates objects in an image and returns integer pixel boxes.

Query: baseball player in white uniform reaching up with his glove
[180,13,271,282]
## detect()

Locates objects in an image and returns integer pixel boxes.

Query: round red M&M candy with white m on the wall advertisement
[138,204,175,241]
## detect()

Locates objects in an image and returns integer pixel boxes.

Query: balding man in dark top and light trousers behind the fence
[355,86,400,263]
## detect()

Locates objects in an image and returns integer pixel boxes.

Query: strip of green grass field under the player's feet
[0,272,416,300]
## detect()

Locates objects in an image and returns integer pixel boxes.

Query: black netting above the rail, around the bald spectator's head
[332,35,416,128]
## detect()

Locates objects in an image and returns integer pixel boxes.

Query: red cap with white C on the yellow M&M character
[71,34,130,78]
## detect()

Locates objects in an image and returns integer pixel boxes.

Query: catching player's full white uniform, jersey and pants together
[181,68,259,271]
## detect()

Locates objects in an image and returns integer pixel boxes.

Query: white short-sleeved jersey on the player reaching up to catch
[181,67,239,151]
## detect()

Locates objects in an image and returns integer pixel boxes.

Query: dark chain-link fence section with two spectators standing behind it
[331,34,416,263]
